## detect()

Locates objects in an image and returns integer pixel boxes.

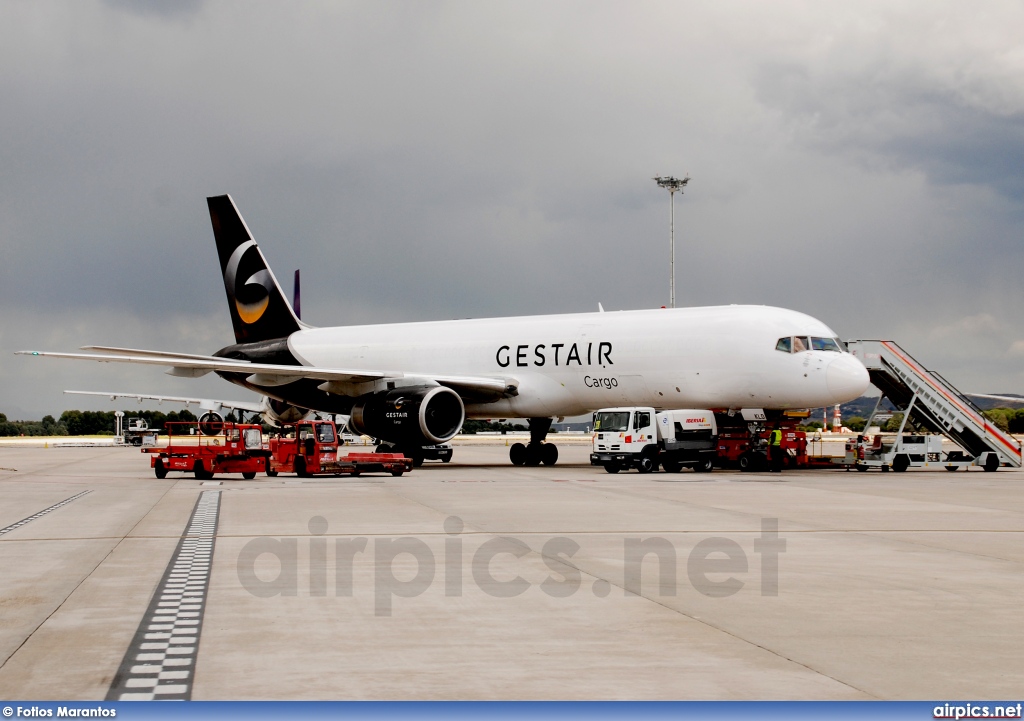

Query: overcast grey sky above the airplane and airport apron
[0,0,1024,419]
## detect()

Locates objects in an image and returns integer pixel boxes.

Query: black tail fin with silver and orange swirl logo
[206,196,302,343]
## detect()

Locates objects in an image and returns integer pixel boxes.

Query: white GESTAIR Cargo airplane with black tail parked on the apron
[19,196,868,465]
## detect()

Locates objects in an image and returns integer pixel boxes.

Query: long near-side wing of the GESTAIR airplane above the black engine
[15,346,519,402]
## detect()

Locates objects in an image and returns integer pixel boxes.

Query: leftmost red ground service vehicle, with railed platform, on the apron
[142,422,268,480]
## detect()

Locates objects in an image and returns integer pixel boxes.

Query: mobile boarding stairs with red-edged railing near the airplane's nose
[848,340,1022,471]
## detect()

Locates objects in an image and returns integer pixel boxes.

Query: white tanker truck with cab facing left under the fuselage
[590,407,718,473]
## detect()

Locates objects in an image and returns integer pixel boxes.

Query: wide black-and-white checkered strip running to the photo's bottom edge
[106,491,221,701]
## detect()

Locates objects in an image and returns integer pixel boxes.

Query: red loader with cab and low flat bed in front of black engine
[274,420,414,477]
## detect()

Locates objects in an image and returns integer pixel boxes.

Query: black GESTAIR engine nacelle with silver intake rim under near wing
[348,386,466,446]
